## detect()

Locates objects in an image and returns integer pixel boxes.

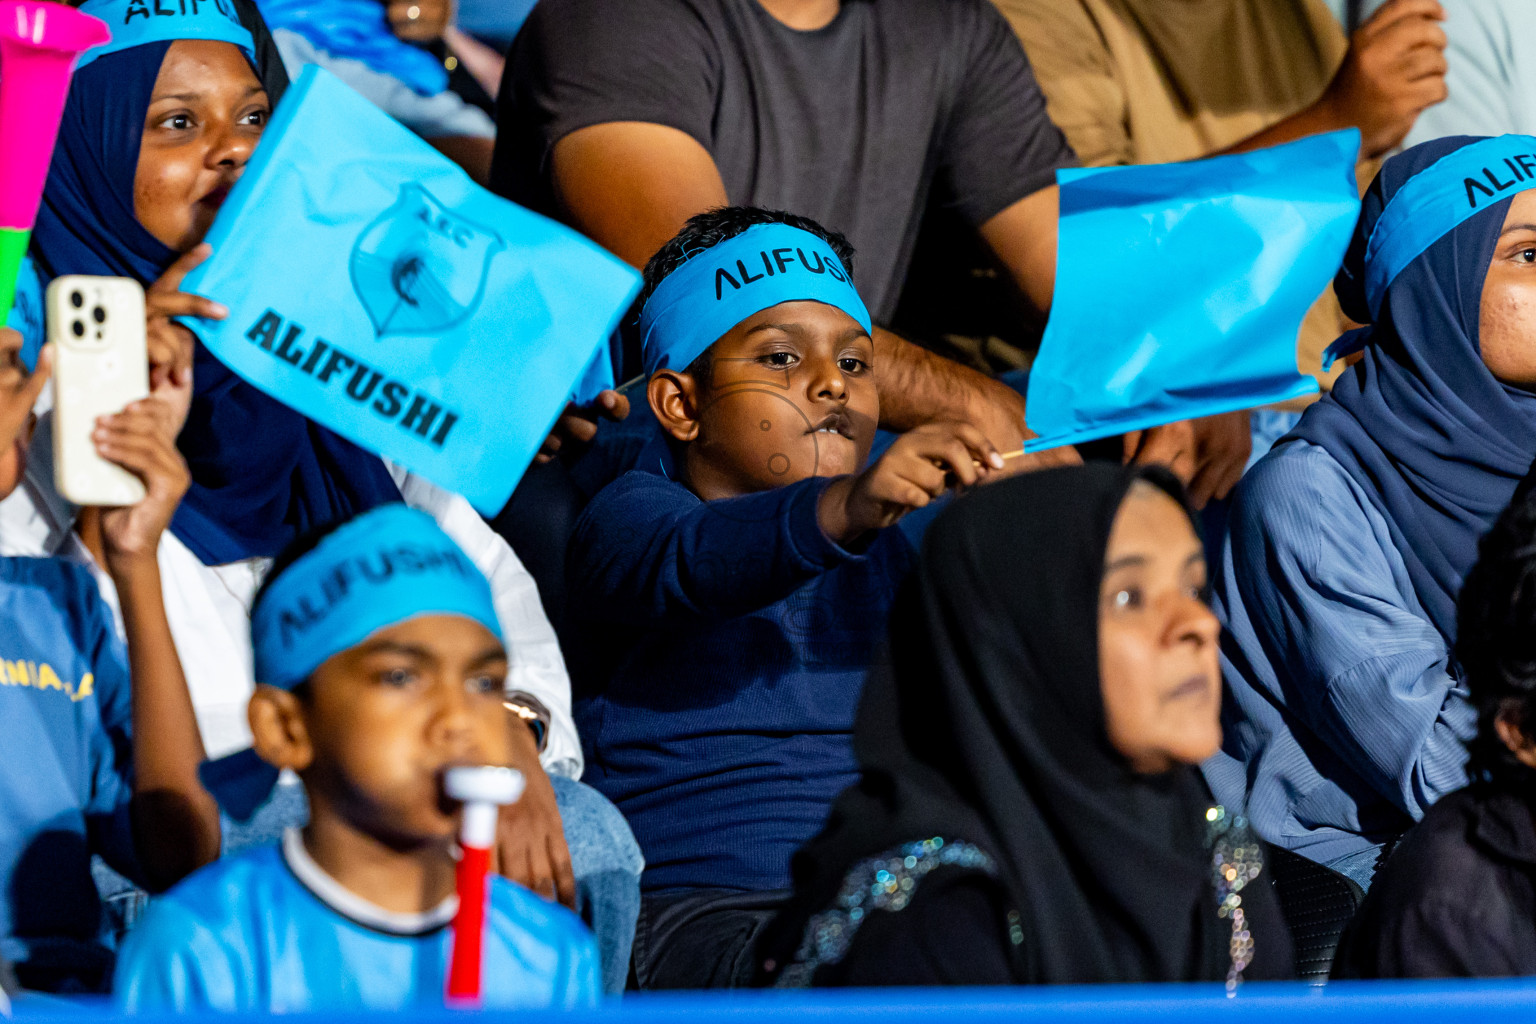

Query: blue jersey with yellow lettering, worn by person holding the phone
[0,557,137,990]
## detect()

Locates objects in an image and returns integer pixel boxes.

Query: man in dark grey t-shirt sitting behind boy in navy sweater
[492,0,1247,493]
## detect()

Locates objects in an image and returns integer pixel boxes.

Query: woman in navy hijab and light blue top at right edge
[1206,135,1536,886]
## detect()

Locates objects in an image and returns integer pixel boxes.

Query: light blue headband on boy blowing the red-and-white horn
[250,505,501,689]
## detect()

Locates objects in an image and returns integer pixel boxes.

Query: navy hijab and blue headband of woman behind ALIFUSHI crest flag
[32,0,399,565]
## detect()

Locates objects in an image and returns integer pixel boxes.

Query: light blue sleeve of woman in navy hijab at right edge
[1224,450,1476,818]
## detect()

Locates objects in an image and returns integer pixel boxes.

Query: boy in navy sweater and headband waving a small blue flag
[568,207,1003,987]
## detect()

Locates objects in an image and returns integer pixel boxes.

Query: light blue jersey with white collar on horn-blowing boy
[114,831,602,1013]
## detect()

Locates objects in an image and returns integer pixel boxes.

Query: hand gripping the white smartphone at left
[91,398,192,571]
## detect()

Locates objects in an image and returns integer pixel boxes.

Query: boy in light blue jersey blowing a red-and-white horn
[115,505,602,1012]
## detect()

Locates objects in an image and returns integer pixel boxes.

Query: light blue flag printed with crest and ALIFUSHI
[183,66,641,514]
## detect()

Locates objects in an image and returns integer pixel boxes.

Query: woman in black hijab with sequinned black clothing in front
[759,465,1292,989]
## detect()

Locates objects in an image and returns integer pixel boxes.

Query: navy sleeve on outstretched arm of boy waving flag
[568,471,860,625]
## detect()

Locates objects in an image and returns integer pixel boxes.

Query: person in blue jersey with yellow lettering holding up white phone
[0,330,220,992]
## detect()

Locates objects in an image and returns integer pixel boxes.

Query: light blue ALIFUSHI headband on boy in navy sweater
[641,224,874,376]
